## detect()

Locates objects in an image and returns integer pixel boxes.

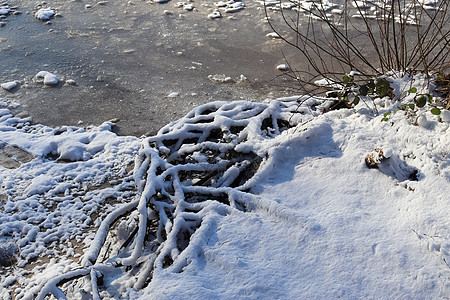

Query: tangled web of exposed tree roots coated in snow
[39,98,330,298]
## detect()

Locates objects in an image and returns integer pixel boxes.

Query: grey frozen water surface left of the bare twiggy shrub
[0,0,298,135]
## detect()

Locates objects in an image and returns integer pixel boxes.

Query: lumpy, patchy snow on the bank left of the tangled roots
[0,109,141,299]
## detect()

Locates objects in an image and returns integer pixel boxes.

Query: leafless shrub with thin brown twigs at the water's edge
[264,0,450,93]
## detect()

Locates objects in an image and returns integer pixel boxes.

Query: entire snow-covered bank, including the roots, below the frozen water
[0,73,450,299]
